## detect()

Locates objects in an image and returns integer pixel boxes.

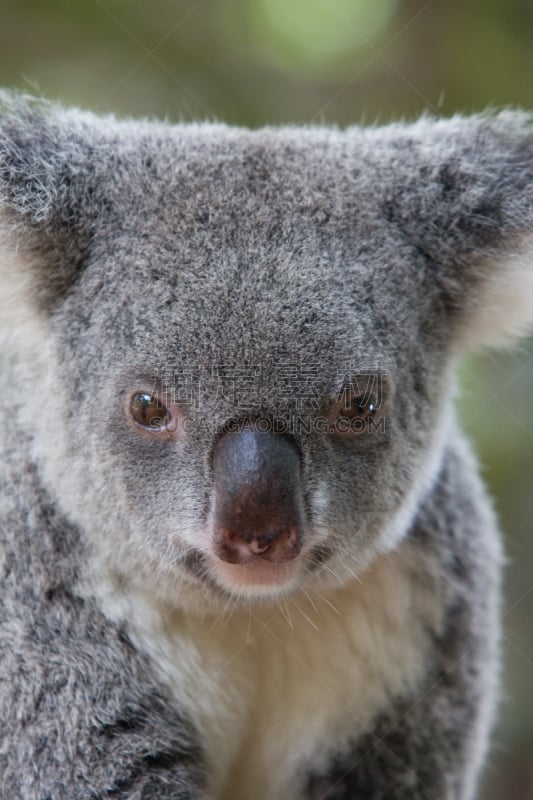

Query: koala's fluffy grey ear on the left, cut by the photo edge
[0,91,105,318]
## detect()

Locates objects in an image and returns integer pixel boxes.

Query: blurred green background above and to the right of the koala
[0,0,533,800]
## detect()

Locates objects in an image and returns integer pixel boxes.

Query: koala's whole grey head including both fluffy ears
[0,90,533,602]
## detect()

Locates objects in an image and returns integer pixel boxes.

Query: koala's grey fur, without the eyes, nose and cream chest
[0,93,533,800]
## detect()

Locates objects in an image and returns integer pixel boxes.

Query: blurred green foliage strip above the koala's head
[0,0,533,125]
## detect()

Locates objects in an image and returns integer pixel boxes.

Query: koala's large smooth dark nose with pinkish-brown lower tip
[214,429,303,564]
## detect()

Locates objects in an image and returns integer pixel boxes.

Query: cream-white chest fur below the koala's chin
[92,544,439,800]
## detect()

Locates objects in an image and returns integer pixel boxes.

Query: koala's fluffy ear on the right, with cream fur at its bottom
[378,111,533,351]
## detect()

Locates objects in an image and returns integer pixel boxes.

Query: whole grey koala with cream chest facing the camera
[0,91,533,800]
